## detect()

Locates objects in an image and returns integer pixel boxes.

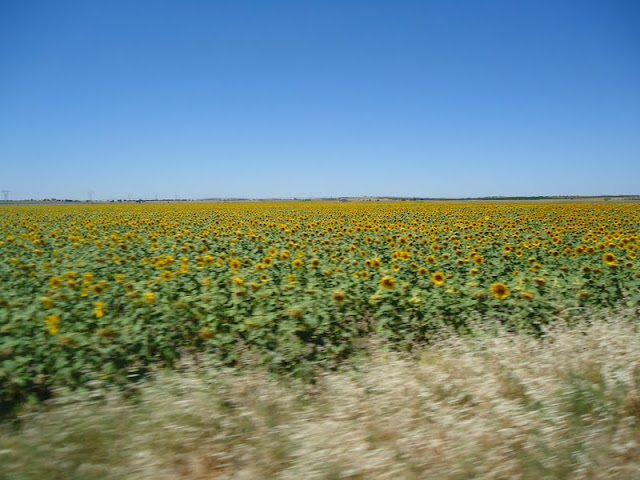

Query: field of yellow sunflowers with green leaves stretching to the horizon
[0,202,640,412]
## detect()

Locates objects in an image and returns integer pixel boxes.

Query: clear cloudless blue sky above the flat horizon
[0,0,640,199]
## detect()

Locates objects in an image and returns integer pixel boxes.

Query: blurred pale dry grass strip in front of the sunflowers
[0,313,640,480]
